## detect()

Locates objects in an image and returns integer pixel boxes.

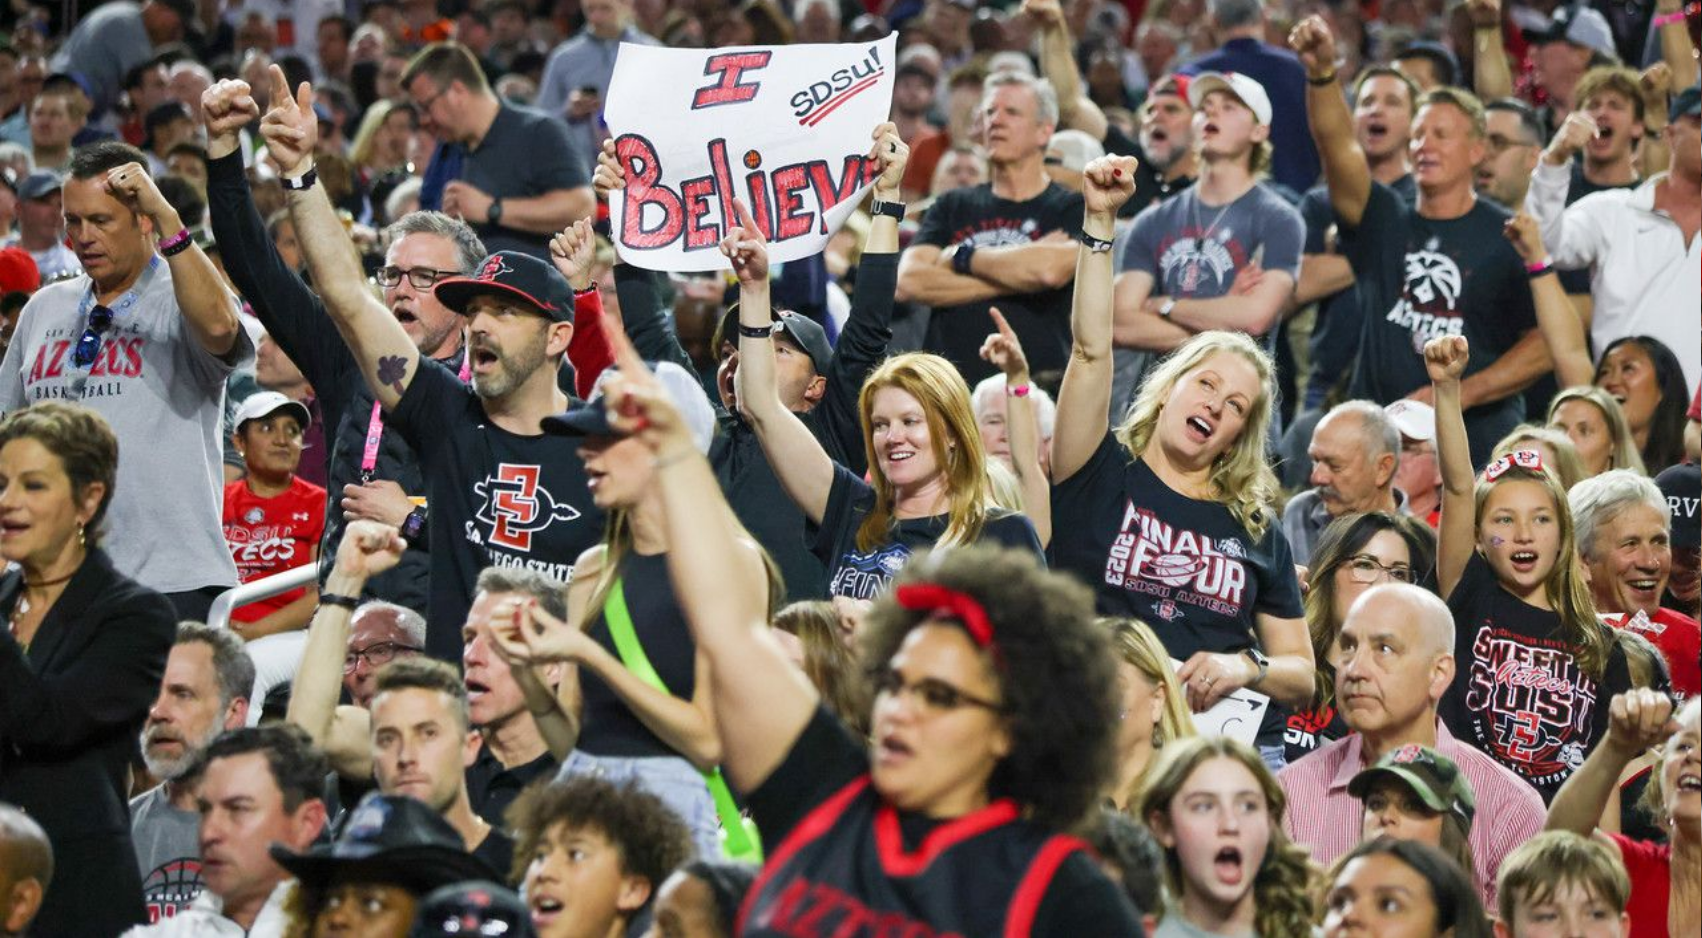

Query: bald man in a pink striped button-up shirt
[1277,584,1544,909]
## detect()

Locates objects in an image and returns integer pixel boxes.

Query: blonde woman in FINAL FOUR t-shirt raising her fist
[1052,157,1312,766]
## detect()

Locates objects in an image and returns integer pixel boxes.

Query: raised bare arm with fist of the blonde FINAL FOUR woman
[1052,157,1137,482]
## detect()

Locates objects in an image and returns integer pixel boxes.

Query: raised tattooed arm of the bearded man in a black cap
[260,65,420,410]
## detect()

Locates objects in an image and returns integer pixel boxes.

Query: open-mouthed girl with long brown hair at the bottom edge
[1137,735,1314,938]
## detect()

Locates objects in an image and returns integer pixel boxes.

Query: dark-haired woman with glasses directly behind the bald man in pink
[1283,511,1436,763]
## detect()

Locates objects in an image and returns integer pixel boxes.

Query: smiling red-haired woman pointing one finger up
[722,201,1042,599]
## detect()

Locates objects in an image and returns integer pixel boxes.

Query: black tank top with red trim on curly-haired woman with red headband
[739,775,1086,938]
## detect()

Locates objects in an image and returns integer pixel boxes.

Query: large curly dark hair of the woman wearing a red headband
[861,546,1118,831]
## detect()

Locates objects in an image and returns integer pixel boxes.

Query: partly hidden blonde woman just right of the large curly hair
[1099,618,1195,812]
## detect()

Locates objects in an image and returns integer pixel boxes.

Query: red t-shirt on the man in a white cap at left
[225,477,325,621]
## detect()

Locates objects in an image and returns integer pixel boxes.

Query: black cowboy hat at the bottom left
[272,792,494,895]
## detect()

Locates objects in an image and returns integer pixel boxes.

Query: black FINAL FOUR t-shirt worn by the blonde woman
[1052,432,1304,744]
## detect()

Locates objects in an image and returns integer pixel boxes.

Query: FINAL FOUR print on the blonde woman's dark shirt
[1105,500,1248,616]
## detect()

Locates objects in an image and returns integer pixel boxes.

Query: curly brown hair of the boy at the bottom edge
[505,776,694,894]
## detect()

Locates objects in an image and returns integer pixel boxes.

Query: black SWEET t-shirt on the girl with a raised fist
[1442,555,1631,802]
